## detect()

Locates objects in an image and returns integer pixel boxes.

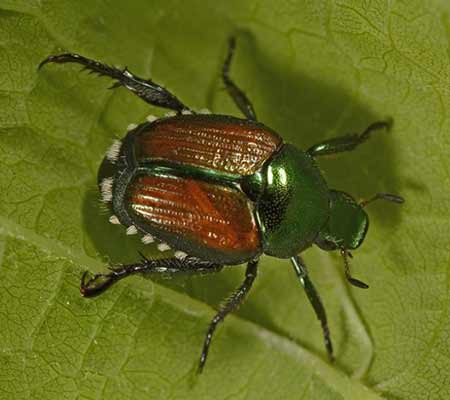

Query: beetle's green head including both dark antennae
[315,190,404,288]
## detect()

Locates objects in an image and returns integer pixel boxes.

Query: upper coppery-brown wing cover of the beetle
[134,115,282,175]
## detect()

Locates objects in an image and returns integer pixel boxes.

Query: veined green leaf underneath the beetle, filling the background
[0,0,450,400]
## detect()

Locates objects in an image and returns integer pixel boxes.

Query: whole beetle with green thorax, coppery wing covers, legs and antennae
[39,38,404,372]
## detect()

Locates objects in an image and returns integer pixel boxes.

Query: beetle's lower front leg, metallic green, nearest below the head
[291,256,334,361]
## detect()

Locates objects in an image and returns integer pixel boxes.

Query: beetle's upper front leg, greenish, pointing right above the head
[307,120,392,157]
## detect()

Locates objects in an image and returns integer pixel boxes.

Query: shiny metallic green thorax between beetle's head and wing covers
[256,144,329,258]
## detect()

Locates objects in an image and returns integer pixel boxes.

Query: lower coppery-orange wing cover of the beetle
[127,175,260,262]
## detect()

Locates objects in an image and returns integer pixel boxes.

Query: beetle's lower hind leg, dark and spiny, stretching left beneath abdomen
[80,254,223,297]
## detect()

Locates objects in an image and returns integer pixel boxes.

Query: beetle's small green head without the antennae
[316,190,369,250]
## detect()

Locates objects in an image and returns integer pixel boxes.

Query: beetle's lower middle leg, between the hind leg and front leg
[198,260,258,373]
